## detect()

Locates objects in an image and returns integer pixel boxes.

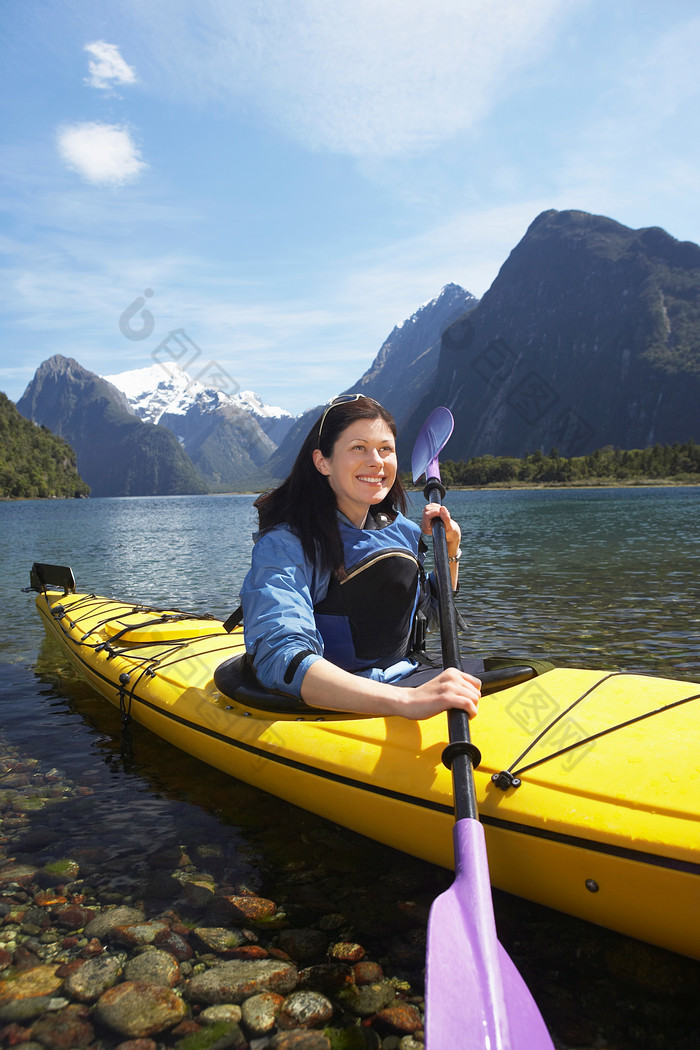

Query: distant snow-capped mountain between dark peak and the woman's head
[104,362,293,490]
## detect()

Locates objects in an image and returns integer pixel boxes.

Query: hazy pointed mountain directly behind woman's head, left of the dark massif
[264,285,479,483]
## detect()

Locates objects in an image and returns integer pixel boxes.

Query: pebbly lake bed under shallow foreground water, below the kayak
[0,739,700,1050]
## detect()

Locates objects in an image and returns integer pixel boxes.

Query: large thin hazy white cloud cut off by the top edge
[110,0,586,158]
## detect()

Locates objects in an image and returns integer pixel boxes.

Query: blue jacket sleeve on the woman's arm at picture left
[240,528,323,696]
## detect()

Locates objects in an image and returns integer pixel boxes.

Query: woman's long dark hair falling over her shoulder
[255,395,406,574]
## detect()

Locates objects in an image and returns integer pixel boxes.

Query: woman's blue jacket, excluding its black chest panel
[240,515,434,696]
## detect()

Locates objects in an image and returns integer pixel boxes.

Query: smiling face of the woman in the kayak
[314,417,398,528]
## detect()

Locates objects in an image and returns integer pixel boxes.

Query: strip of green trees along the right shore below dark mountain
[404,441,700,488]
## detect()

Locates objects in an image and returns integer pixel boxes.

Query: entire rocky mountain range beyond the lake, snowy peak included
[12,209,700,495]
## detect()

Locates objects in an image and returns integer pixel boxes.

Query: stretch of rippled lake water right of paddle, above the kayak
[432,488,700,679]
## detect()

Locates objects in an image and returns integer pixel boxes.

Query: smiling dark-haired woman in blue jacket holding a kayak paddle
[240,394,481,718]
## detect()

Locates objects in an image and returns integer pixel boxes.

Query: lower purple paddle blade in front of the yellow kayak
[425,818,553,1050]
